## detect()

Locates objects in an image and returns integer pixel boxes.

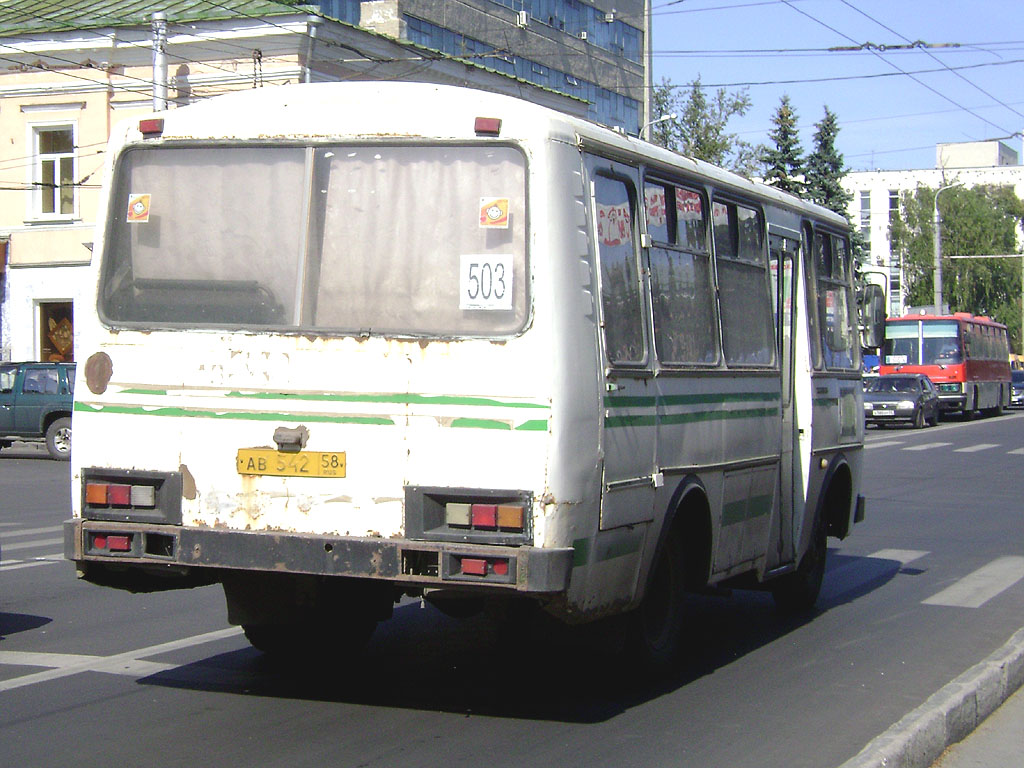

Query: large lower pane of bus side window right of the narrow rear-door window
[649,248,718,365]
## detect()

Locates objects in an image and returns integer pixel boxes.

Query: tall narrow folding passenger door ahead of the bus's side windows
[768,231,803,565]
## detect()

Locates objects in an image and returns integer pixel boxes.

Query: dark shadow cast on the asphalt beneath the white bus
[140,552,900,723]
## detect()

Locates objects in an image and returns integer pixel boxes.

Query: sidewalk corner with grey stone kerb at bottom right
[841,629,1024,768]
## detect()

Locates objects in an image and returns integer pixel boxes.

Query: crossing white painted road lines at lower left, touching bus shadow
[0,627,242,693]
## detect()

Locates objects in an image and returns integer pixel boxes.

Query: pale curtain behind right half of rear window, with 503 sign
[310,146,526,336]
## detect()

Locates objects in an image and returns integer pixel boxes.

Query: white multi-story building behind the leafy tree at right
[843,141,1024,316]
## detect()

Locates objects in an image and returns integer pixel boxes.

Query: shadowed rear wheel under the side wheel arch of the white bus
[626,535,684,671]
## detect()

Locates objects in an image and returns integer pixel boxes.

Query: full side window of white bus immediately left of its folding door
[712,202,775,366]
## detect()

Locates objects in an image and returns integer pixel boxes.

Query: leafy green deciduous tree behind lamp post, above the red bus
[892,186,1024,349]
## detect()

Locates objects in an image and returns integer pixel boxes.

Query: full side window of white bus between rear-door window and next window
[644,183,718,366]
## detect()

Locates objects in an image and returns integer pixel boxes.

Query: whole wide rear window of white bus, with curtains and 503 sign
[99,144,527,337]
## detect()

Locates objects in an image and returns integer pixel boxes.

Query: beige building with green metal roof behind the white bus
[0,0,588,360]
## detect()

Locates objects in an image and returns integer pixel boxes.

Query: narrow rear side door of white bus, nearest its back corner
[586,155,657,530]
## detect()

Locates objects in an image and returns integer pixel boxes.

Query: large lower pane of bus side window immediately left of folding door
[718,259,775,366]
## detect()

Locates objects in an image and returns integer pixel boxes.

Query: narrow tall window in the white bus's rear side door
[594,176,645,364]
